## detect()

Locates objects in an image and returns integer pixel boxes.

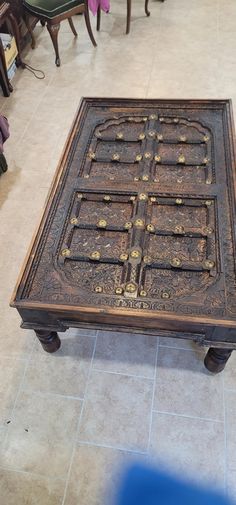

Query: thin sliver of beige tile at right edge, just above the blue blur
[225,391,236,470]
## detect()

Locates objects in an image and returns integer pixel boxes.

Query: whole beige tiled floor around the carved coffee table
[0,0,236,505]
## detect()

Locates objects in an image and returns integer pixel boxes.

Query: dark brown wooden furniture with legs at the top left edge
[0,2,22,96]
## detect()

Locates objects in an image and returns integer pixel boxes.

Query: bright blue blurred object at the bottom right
[116,464,232,505]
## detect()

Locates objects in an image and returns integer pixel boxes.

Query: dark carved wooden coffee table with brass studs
[11,98,236,373]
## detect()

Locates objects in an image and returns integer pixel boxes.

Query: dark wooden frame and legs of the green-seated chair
[24,0,97,67]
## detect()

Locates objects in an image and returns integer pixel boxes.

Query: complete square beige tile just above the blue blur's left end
[78,371,153,451]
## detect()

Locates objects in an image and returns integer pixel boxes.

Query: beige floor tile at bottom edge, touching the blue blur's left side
[65,445,142,505]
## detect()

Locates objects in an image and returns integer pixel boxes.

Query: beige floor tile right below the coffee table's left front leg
[23,333,94,398]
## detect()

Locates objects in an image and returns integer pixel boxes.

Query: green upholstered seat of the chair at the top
[23,0,84,19]
